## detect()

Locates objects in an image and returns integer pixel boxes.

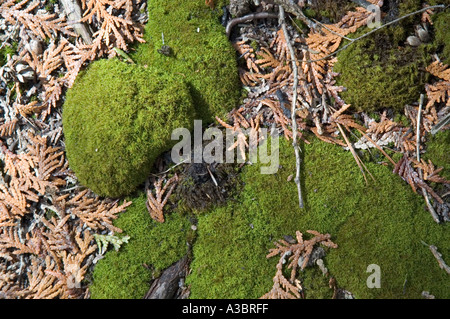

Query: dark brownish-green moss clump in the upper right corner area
[334,0,450,113]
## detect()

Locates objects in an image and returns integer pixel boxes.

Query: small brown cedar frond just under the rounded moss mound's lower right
[145,174,178,223]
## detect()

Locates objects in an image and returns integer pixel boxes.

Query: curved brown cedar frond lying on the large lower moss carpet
[261,230,337,299]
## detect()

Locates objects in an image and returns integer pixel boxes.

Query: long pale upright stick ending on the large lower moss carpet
[279,5,303,208]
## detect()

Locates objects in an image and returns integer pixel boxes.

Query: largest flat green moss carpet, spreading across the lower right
[187,140,450,298]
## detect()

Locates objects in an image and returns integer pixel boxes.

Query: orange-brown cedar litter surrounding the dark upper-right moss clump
[218,0,450,222]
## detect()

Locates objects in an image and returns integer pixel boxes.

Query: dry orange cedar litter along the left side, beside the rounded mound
[0,0,142,298]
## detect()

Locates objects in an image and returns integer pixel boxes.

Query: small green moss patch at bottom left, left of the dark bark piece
[89,194,190,299]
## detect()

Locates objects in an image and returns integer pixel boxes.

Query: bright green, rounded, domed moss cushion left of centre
[63,59,195,197]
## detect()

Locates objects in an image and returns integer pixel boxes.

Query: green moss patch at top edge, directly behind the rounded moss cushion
[132,0,240,122]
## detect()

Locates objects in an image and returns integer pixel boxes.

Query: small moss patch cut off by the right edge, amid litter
[423,130,450,180]
